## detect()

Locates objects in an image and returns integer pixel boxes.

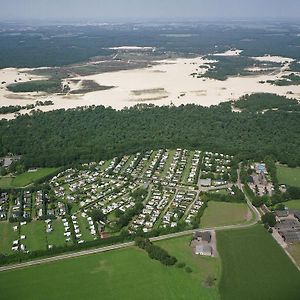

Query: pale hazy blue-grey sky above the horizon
[0,0,300,21]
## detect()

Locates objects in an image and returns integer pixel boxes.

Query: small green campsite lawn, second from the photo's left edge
[20,221,47,251]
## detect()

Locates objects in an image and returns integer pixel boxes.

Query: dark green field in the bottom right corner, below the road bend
[217,226,300,300]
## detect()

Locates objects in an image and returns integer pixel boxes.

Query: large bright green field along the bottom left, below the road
[0,240,219,300]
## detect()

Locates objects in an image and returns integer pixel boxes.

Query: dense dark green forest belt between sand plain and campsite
[0,103,300,167]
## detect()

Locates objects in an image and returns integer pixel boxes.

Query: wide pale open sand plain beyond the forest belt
[0,50,300,119]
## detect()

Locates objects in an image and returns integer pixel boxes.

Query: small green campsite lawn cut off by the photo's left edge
[0,222,19,255]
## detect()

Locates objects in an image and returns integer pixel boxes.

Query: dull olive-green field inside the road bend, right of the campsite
[201,201,251,228]
